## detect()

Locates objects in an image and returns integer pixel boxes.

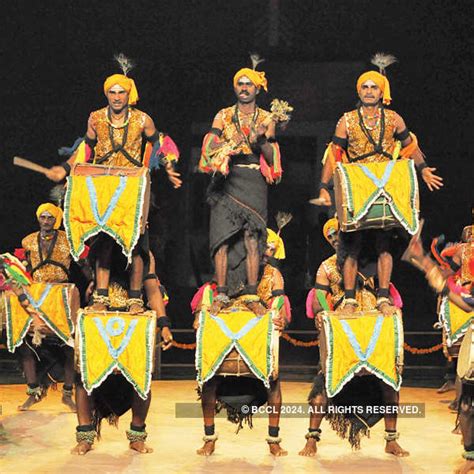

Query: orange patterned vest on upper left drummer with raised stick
[90,107,146,168]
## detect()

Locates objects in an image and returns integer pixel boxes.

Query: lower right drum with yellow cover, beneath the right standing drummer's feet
[319,310,403,398]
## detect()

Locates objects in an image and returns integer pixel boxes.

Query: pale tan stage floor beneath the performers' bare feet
[0,381,463,473]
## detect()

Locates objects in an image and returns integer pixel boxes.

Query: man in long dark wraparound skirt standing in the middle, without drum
[199,55,282,313]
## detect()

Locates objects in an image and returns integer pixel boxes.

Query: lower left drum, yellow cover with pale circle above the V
[75,309,156,400]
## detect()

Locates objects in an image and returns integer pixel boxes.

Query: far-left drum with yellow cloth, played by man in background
[3,283,80,352]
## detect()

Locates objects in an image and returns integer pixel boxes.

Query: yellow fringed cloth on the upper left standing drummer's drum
[64,176,146,261]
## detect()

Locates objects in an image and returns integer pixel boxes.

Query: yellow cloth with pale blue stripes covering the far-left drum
[5,283,74,352]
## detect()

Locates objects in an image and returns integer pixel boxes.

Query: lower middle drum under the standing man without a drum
[196,301,280,386]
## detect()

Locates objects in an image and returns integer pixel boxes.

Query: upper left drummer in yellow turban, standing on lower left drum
[47,61,182,313]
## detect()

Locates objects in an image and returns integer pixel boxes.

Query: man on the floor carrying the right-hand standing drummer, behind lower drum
[299,218,409,457]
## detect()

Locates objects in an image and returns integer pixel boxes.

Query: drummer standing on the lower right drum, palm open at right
[318,54,443,314]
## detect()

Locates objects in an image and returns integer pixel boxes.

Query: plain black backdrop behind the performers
[0,0,474,378]
